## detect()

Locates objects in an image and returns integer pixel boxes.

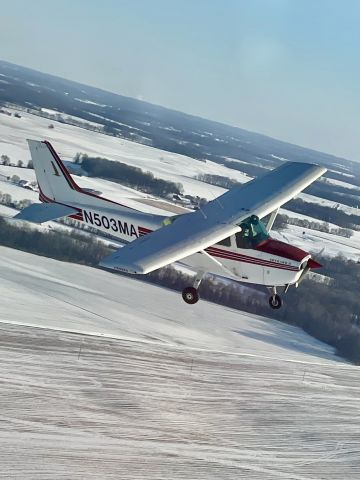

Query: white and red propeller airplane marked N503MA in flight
[14,140,326,309]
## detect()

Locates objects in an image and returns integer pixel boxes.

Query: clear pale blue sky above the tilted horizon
[0,0,360,161]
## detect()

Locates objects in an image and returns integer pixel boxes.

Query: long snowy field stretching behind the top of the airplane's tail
[0,109,249,198]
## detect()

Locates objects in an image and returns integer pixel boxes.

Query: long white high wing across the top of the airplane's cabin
[100,162,326,274]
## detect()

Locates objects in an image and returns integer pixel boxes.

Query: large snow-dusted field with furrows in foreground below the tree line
[0,248,360,480]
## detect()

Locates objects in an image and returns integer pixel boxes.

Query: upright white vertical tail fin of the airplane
[27,140,81,202]
